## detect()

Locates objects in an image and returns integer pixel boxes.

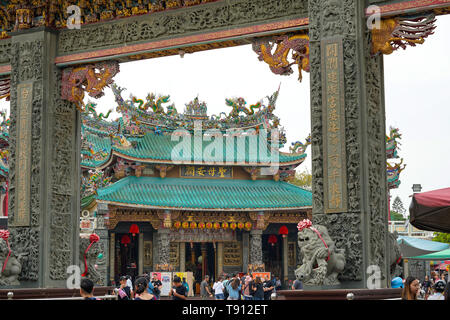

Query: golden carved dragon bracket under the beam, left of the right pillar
[253,34,310,81]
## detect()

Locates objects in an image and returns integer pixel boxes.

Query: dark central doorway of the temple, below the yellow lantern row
[184,242,217,295]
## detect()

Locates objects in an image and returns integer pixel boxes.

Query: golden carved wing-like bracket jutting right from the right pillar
[372,13,436,55]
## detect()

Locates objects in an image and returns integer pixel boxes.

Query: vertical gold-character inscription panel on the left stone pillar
[14,83,33,226]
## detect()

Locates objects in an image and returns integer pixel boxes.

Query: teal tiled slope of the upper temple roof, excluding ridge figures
[81,126,307,168]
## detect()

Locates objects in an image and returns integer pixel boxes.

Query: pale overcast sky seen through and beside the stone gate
[0,16,450,216]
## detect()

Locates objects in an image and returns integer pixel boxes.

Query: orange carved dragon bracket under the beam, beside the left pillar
[61,61,119,112]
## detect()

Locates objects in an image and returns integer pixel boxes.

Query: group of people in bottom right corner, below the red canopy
[391,272,450,300]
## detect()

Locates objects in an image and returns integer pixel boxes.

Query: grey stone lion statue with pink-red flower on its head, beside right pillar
[295,220,345,286]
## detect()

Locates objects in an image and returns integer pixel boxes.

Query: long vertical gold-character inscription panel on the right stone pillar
[322,38,347,213]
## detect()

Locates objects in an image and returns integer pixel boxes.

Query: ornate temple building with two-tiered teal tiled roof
[80,85,312,283]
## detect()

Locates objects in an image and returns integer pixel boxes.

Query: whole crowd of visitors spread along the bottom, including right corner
[80,272,450,300]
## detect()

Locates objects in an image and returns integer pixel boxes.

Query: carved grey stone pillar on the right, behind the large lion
[309,0,389,288]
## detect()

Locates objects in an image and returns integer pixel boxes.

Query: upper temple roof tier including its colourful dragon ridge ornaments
[81,85,310,169]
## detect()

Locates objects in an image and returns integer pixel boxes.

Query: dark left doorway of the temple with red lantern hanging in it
[114,233,139,281]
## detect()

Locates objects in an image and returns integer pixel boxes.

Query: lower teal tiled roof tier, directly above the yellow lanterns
[96,176,312,211]
